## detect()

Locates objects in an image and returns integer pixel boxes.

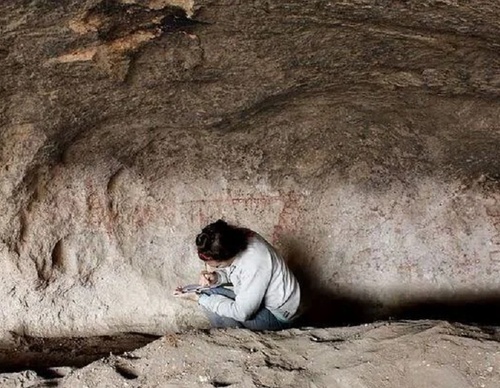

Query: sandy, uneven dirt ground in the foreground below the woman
[0,321,500,388]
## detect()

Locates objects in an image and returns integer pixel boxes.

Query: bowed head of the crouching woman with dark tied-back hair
[196,220,248,267]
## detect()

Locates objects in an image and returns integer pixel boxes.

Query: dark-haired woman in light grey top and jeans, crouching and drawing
[183,220,300,330]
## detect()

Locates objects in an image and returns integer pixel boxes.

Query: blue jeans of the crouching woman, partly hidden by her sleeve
[202,287,292,331]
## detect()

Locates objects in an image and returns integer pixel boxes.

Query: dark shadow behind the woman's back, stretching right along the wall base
[281,239,500,327]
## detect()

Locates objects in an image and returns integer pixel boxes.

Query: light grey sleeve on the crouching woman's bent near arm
[199,252,272,322]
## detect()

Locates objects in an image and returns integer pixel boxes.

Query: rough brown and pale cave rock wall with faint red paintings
[0,0,500,340]
